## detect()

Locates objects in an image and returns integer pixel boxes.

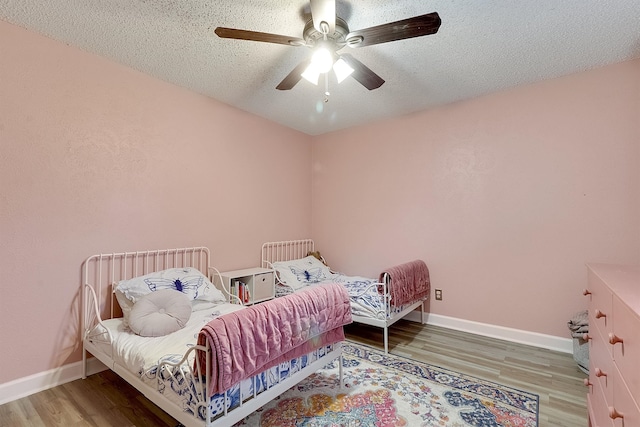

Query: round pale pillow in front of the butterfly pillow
[129,289,191,337]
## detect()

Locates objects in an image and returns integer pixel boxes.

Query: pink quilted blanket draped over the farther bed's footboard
[380,260,431,307]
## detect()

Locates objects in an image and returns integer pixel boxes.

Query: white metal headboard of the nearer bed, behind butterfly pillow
[82,246,211,325]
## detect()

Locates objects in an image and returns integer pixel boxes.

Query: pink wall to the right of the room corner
[312,60,640,337]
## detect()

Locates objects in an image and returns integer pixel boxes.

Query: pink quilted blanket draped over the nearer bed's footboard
[198,284,351,395]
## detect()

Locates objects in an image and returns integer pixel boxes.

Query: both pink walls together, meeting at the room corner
[0,16,640,390]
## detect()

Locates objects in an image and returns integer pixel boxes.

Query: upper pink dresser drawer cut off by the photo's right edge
[607,296,640,400]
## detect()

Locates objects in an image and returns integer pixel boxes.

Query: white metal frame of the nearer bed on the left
[80,247,342,427]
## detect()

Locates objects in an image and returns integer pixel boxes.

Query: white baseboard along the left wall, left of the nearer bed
[0,358,107,405]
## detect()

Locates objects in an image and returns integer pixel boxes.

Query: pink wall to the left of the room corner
[0,21,311,384]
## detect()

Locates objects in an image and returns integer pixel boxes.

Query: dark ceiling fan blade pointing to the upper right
[346,12,442,47]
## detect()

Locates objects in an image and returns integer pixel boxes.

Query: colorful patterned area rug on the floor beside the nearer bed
[237,342,538,427]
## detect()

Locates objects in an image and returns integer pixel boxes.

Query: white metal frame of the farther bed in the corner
[262,239,429,354]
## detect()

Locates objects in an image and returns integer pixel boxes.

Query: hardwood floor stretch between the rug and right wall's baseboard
[347,320,588,427]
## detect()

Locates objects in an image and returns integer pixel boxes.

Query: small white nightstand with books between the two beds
[212,267,276,305]
